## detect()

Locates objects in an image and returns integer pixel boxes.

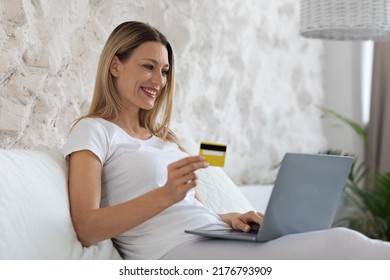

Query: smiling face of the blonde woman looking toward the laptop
[110,42,169,110]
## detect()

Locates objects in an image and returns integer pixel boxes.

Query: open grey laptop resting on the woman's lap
[185,153,353,242]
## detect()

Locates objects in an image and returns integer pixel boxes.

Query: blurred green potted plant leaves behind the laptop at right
[323,109,390,241]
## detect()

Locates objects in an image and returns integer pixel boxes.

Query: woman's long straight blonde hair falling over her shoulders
[76,21,182,149]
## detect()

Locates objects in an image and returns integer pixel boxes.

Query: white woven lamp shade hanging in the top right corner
[300,0,390,41]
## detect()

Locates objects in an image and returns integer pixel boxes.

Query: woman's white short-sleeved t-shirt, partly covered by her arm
[63,118,228,259]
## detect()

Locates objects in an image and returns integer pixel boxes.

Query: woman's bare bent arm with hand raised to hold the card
[69,150,207,246]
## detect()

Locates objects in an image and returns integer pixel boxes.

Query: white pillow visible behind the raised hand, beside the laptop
[181,139,254,213]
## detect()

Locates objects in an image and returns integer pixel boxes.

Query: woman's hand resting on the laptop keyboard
[219,211,264,232]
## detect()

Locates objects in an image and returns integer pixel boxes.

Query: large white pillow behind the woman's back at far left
[0,150,120,259]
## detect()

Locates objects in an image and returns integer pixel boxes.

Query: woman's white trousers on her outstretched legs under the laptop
[161,228,390,260]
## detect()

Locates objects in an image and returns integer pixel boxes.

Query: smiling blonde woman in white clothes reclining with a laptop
[63,22,390,259]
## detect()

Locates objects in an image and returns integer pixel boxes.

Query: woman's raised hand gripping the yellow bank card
[163,156,209,203]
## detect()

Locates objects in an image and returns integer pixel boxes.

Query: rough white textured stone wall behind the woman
[0,0,325,183]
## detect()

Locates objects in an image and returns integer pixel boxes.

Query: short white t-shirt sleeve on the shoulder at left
[62,118,109,165]
